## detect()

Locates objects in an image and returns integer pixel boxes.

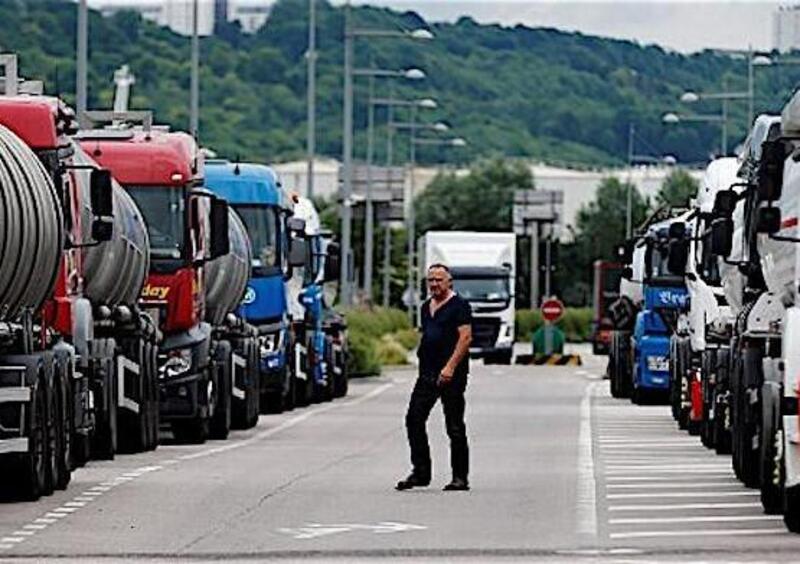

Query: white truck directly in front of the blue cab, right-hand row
[670,157,741,446]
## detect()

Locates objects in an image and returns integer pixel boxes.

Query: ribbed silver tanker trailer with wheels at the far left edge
[0,125,67,499]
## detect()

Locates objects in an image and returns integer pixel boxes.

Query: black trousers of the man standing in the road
[406,375,469,481]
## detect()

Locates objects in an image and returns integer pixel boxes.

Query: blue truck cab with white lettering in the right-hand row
[631,220,689,402]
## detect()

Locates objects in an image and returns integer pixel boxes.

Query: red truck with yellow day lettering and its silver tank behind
[77,111,242,443]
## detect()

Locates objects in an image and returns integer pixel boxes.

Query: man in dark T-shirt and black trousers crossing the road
[396,264,472,491]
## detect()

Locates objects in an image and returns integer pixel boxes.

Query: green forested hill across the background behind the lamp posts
[0,0,800,164]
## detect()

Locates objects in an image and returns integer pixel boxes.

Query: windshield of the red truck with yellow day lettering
[126,186,185,260]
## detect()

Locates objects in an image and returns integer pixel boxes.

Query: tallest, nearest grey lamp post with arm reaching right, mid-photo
[339,1,433,306]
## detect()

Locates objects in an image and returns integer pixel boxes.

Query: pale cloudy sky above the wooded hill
[89,0,784,53]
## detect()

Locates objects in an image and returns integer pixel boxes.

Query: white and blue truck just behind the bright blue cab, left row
[288,194,349,405]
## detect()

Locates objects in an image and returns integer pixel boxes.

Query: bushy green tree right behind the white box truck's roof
[414,159,534,234]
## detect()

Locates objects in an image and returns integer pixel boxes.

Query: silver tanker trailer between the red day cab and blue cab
[205,207,259,432]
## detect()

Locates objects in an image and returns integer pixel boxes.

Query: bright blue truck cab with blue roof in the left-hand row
[205,160,295,413]
